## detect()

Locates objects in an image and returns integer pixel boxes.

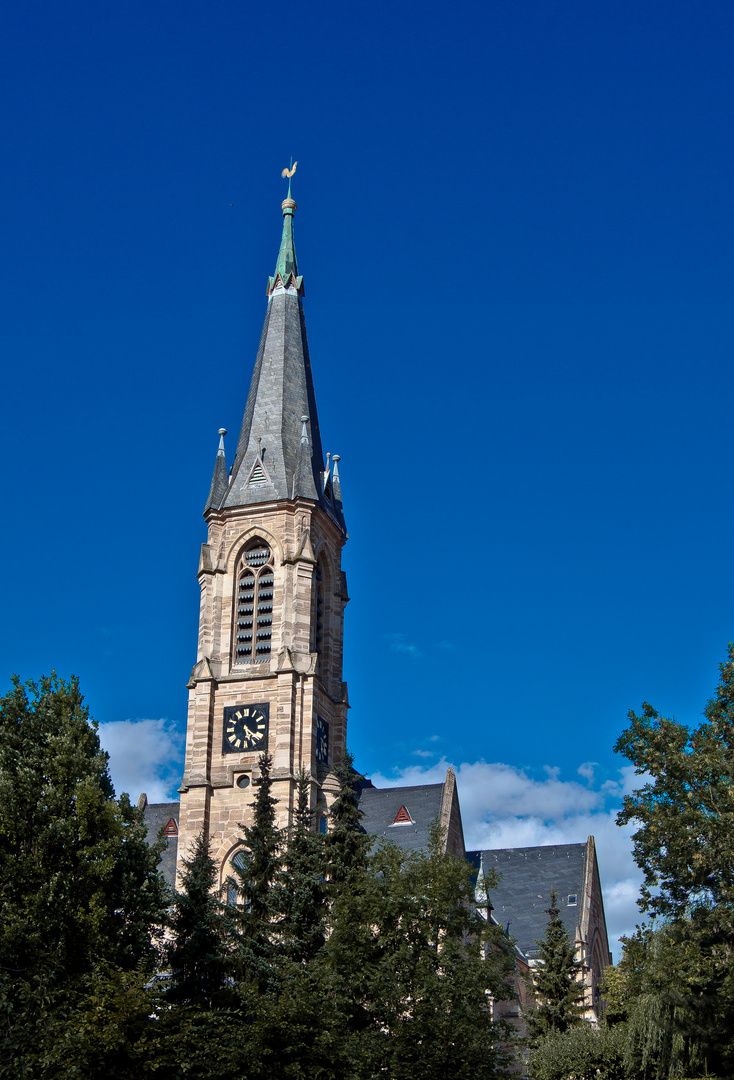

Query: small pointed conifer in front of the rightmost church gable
[526,889,585,1039]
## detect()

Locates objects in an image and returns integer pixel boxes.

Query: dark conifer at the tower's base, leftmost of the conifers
[166,829,226,1009]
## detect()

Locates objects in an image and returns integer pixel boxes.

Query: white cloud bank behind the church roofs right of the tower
[372,757,644,959]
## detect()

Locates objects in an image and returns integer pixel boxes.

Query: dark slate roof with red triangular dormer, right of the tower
[359,784,444,851]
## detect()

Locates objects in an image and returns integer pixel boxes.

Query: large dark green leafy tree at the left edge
[0,674,167,1076]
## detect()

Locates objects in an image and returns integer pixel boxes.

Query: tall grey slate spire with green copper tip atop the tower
[212,189,343,528]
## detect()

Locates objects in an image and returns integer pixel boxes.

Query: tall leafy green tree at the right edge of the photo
[615,645,734,1076]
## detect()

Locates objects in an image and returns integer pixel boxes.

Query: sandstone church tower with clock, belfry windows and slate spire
[178,187,348,883]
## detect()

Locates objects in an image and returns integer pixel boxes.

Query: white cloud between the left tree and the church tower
[99,719,184,802]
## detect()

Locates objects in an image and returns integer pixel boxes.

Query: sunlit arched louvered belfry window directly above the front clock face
[234,540,274,664]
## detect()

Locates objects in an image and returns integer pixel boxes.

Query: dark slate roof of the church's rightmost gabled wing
[467,843,586,959]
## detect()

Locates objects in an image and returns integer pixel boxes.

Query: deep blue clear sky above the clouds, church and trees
[0,0,734,937]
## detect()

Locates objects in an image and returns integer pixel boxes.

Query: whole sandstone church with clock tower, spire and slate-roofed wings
[139,186,610,1018]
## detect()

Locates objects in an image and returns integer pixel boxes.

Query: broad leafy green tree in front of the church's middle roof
[321,825,514,1080]
